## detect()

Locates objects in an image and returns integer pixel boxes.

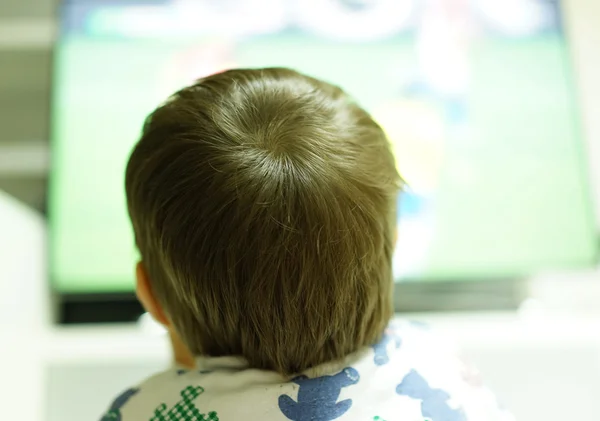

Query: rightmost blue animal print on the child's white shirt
[396,370,467,421]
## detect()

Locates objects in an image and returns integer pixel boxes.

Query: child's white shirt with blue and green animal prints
[101,321,513,421]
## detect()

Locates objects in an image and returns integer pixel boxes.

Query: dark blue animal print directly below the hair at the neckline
[279,367,360,421]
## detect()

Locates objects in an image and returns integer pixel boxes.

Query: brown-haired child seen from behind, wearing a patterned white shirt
[102,68,503,421]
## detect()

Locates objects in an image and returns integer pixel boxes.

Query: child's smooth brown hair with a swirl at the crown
[126,68,400,374]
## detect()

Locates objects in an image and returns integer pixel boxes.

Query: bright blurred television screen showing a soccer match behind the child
[50,0,597,294]
